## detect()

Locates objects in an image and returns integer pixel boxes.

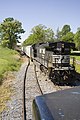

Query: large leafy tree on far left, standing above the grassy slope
[0,18,25,49]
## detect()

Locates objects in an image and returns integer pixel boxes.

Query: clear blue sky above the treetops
[0,0,80,41]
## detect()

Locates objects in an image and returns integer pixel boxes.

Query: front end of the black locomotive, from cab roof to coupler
[46,41,75,83]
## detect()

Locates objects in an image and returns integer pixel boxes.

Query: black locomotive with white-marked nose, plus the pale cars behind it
[24,41,75,84]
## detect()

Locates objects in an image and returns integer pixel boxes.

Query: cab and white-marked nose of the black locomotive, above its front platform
[48,41,75,68]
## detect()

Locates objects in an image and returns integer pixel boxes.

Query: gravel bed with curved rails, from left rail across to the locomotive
[23,60,79,120]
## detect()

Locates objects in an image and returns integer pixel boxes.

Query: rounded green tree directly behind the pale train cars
[23,24,54,45]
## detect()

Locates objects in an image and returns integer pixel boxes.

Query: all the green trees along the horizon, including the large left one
[0,17,80,50]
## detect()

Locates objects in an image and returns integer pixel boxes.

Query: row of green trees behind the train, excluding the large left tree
[23,24,80,50]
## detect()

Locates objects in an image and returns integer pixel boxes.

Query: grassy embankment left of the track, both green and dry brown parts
[0,46,21,112]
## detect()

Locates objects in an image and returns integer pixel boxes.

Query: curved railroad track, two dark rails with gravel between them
[22,60,43,120]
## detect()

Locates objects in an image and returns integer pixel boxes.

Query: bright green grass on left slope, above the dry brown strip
[0,46,21,83]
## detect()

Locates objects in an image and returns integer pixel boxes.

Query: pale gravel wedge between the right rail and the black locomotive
[36,65,72,94]
